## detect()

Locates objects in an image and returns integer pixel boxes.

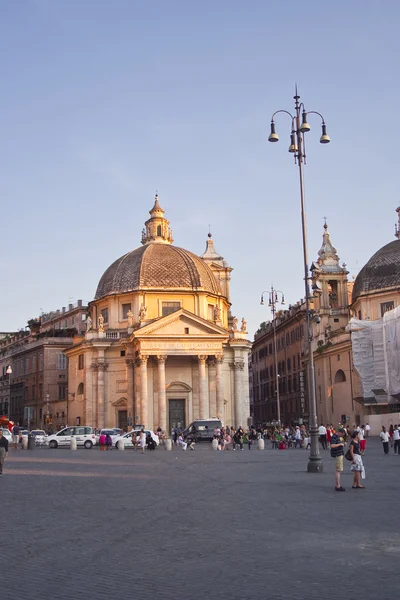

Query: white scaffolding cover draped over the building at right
[347,306,400,400]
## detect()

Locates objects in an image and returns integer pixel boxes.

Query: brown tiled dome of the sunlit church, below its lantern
[95,243,221,300]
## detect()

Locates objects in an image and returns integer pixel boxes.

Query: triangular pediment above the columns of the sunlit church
[134,308,229,340]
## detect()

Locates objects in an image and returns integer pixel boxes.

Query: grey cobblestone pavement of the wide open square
[0,439,400,600]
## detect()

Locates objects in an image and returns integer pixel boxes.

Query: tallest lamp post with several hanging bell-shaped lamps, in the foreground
[268,86,331,473]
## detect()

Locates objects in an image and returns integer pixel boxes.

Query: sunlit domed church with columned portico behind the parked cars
[65,195,251,433]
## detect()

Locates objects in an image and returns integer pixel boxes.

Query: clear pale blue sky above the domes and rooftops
[0,0,400,337]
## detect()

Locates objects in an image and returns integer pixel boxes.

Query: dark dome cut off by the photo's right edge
[352,239,400,302]
